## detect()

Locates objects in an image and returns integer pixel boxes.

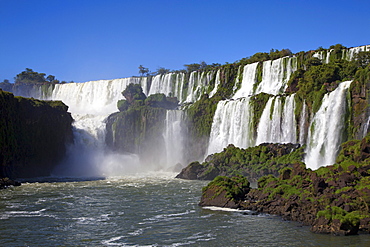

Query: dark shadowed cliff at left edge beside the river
[0,90,73,178]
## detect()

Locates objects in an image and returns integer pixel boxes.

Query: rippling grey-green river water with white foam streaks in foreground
[0,174,370,246]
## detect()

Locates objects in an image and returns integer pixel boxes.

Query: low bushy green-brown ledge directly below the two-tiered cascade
[176,143,303,182]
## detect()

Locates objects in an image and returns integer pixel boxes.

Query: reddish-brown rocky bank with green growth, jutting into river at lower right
[200,136,370,235]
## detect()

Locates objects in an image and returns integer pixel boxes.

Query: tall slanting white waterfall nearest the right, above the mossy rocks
[304,81,351,169]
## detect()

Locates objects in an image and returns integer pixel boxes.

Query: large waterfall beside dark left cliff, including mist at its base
[45,78,147,176]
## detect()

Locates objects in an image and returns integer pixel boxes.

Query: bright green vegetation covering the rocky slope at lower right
[258,131,370,233]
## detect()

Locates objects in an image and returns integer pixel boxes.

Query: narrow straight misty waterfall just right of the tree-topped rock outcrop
[163,110,185,168]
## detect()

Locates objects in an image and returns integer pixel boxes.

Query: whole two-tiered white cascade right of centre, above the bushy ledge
[207,57,297,155]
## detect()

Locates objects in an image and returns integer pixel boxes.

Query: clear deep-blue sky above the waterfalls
[0,0,370,82]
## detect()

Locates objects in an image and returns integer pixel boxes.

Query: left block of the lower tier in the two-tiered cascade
[207,98,254,154]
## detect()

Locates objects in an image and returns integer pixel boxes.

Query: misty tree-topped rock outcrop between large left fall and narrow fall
[105,84,178,164]
